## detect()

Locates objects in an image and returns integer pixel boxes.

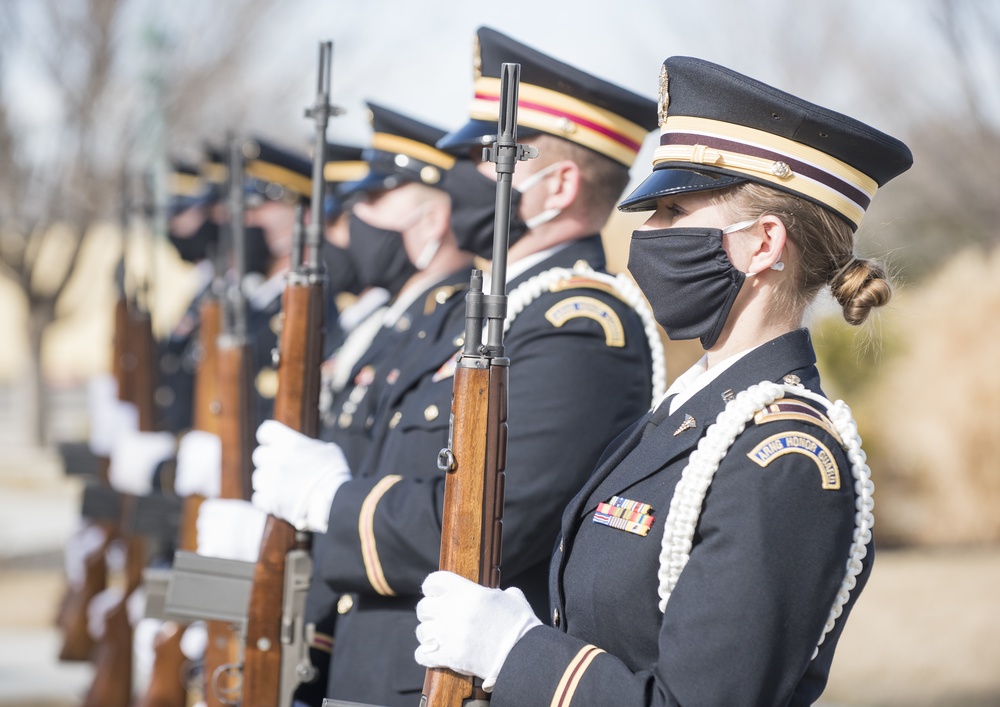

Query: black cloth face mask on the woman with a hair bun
[628,228,746,349]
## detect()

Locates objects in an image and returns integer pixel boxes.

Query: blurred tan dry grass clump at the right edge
[859,250,1000,545]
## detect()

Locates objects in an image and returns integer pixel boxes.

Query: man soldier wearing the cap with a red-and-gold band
[254,24,663,705]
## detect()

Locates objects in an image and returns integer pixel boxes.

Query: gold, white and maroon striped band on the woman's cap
[653,116,878,226]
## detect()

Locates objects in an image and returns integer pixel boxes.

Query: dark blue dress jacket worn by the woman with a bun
[492,329,872,707]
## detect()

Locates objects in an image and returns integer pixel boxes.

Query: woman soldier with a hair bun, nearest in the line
[416,57,912,707]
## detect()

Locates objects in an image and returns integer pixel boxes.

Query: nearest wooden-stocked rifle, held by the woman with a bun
[420,63,538,707]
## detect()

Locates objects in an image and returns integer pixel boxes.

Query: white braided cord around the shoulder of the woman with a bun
[658,381,875,658]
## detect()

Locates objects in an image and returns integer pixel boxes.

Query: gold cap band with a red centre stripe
[469,76,649,167]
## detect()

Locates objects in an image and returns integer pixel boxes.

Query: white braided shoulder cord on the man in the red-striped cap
[504,263,667,403]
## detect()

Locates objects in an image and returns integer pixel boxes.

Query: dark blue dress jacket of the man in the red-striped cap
[315,236,652,707]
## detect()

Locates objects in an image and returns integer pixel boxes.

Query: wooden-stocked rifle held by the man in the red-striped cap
[243,41,333,707]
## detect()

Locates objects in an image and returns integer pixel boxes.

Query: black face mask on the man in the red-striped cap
[448,160,528,259]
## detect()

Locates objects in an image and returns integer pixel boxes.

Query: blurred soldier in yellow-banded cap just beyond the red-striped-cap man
[286,103,472,704]
